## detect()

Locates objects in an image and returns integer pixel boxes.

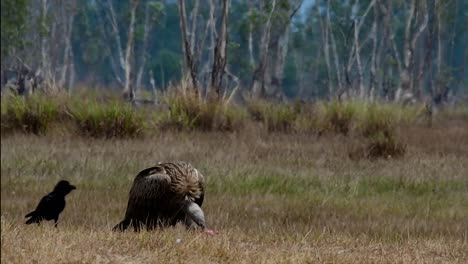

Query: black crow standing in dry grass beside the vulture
[25,180,76,227]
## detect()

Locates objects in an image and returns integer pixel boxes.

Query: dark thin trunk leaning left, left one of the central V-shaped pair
[178,0,199,96]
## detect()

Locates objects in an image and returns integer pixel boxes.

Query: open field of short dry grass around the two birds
[1,115,468,263]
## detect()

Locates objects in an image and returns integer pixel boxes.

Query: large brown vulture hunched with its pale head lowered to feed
[114,161,206,231]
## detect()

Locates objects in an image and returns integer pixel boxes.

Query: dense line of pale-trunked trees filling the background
[1,0,468,101]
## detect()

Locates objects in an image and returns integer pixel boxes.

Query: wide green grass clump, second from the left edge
[70,101,145,138]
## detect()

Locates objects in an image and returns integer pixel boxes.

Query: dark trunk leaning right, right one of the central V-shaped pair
[211,0,229,99]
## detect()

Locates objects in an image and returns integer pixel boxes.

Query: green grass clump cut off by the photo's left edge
[1,95,59,135]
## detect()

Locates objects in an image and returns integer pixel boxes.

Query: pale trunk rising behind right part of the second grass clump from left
[123,0,138,101]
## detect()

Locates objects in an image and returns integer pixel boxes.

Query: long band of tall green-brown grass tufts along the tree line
[1,87,458,151]
